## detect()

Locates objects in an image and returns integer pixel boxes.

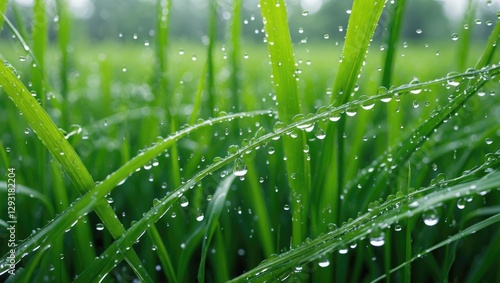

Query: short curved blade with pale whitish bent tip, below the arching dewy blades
[198,175,236,282]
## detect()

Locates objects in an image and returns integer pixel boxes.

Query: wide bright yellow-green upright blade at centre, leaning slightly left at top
[260,0,311,246]
